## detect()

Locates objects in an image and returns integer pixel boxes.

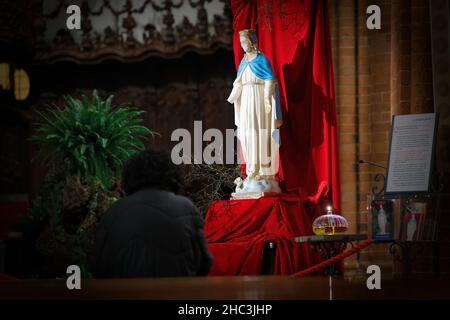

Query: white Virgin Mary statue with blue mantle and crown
[228,30,282,196]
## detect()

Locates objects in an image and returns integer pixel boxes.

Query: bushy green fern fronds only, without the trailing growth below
[32,90,156,189]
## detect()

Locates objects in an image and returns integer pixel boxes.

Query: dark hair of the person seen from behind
[122,149,180,195]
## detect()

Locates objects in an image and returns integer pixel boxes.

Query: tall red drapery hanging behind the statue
[231,0,341,212]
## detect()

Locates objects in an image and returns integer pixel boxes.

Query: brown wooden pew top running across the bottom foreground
[0,276,450,300]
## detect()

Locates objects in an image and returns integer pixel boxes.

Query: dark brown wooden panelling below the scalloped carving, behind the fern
[30,50,236,150]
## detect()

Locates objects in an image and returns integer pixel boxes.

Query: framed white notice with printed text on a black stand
[385,113,438,195]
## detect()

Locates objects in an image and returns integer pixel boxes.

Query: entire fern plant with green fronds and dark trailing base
[22,91,156,277]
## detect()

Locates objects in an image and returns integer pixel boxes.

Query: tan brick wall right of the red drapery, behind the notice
[329,0,446,275]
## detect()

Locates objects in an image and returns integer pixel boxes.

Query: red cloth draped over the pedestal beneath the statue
[205,195,318,276]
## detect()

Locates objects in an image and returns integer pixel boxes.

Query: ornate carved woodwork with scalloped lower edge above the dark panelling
[31,0,233,63]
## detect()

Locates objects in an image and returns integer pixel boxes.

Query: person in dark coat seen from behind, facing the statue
[95,150,212,278]
